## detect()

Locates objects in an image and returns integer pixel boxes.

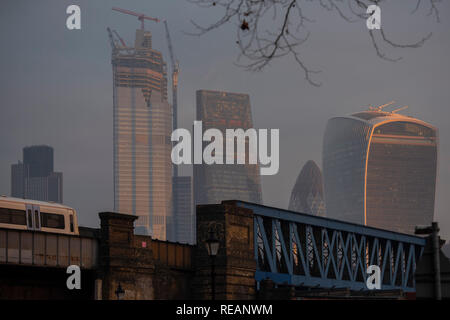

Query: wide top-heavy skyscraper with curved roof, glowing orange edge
[323,108,437,233]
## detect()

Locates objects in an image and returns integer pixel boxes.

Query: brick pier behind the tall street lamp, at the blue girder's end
[192,201,256,299]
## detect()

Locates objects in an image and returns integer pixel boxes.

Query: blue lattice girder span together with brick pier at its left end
[196,200,426,298]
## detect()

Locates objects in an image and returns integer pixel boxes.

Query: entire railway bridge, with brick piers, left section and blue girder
[0,200,432,299]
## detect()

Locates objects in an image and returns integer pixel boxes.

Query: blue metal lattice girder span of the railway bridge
[236,201,425,292]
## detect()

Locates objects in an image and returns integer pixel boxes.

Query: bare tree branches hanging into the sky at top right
[187,0,442,86]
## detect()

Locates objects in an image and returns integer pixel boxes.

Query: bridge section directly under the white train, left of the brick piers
[0,228,98,299]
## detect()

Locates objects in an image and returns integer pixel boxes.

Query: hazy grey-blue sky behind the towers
[0,0,450,239]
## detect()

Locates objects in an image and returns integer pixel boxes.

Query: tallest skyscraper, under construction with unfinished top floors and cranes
[109,30,172,240]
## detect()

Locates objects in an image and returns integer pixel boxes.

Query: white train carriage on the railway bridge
[0,196,79,235]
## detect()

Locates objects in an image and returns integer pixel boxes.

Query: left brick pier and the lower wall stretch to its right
[99,212,193,300]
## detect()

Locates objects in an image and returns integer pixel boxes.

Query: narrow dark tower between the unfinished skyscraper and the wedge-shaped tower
[172,176,195,244]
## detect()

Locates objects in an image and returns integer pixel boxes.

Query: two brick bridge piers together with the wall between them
[99,202,256,299]
